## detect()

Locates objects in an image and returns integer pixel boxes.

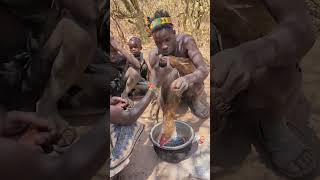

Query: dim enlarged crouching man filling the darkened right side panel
[211,0,316,178]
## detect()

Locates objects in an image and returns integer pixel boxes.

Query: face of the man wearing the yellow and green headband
[152,29,176,55]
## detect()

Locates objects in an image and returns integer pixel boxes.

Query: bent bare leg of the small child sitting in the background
[121,67,140,99]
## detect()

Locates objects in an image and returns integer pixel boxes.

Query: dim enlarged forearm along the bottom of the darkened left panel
[0,116,109,180]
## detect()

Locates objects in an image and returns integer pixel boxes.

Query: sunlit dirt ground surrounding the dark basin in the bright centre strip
[112,77,210,180]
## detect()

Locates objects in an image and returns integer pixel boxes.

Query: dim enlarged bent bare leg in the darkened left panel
[37,18,96,130]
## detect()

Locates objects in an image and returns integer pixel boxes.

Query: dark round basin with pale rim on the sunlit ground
[150,120,194,163]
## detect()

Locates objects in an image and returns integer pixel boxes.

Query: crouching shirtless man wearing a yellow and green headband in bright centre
[149,10,209,119]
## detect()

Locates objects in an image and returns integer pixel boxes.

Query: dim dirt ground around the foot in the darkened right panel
[211,38,320,180]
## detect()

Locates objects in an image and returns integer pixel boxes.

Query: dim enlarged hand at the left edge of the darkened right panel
[211,48,256,103]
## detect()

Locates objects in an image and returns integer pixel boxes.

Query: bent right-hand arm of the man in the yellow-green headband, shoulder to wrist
[184,38,209,84]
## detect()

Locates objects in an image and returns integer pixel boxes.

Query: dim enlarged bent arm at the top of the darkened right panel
[238,0,315,68]
